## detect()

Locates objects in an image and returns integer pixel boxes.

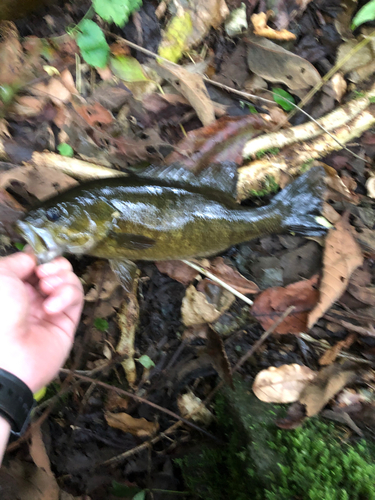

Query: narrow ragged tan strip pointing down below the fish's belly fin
[116,270,139,386]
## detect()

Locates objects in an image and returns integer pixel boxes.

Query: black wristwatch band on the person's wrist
[0,368,34,437]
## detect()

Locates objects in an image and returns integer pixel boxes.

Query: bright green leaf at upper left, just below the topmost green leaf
[76,19,109,68]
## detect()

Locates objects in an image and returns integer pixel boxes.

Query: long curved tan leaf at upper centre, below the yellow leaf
[156,62,215,126]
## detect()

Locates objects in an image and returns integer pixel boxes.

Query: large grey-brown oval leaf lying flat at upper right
[246,35,321,90]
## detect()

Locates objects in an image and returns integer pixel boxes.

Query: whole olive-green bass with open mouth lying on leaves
[16,162,326,289]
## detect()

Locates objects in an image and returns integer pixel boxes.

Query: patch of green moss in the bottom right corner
[178,380,375,500]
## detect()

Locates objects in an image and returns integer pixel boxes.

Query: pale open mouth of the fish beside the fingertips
[16,221,64,264]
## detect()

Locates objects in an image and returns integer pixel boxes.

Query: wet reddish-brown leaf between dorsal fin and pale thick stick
[166,115,273,172]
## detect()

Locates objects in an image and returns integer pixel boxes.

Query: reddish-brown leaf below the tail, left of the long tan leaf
[251,275,319,334]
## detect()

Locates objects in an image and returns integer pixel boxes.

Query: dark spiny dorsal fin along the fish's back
[136,162,237,201]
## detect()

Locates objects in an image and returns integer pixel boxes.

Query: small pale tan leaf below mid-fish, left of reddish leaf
[181,280,235,326]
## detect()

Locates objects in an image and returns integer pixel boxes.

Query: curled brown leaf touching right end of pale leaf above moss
[299,363,356,417]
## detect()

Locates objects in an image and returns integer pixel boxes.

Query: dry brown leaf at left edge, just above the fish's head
[0,165,78,201]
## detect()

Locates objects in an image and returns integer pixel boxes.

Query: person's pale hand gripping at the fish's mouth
[0,253,83,393]
